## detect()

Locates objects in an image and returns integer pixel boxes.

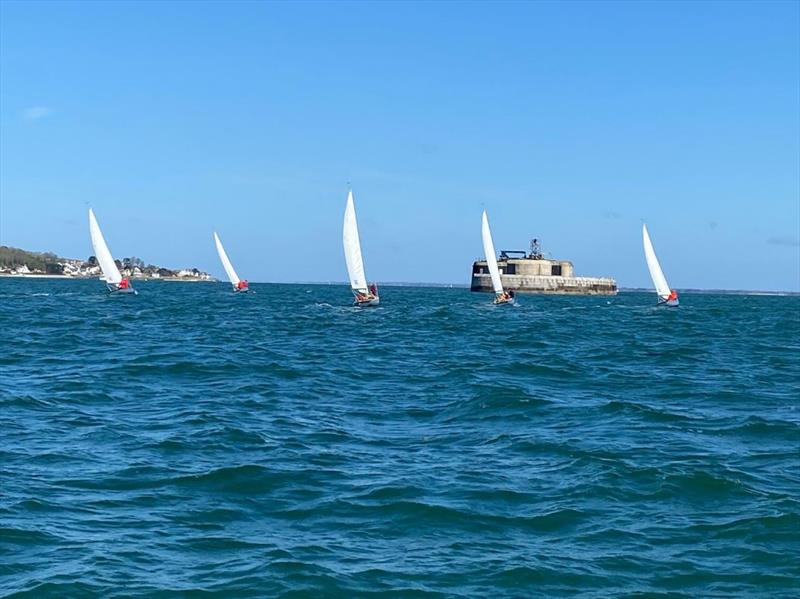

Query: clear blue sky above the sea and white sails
[0,1,800,291]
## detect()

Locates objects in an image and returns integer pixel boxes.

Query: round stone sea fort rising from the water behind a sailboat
[470,239,617,295]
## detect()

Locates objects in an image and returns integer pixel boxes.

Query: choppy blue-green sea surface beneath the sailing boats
[0,279,800,598]
